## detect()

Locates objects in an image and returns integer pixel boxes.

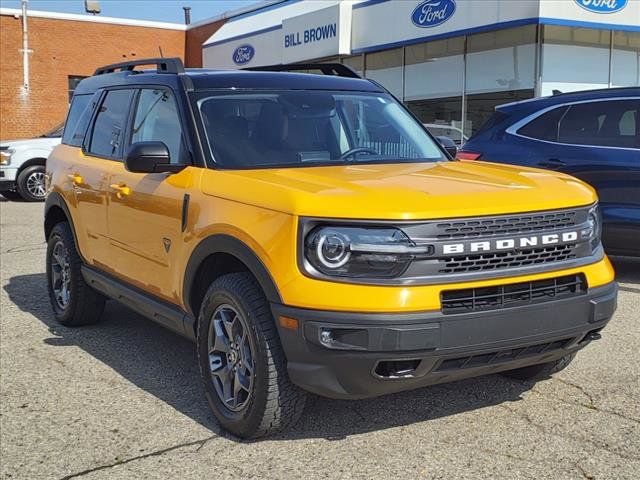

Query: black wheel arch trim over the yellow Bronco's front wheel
[183,234,282,318]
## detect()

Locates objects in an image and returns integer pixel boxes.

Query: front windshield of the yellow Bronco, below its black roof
[198,91,447,169]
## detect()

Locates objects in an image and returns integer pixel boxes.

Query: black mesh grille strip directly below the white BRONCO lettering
[438,244,577,273]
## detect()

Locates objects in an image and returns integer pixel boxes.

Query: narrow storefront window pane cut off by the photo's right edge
[611,32,640,87]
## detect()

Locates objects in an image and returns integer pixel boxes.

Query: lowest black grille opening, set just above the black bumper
[440,274,587,314]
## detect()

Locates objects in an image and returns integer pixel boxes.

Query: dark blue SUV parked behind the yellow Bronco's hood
[458,88,640,256]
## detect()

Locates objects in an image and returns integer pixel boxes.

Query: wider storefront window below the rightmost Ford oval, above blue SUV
[541,25,611,96]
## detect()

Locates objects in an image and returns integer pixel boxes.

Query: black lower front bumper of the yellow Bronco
[272,282,618,399]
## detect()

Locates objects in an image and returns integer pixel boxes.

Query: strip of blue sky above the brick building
[0,0,259,23]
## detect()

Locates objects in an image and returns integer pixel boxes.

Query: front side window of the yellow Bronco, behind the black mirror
[131,89,187,163]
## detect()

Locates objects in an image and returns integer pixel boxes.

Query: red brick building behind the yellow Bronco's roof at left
[0,8,225,140]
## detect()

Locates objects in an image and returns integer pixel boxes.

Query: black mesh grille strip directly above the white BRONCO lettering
[436,210,578,240]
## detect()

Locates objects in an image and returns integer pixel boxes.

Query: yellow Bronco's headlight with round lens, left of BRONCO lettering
[304,226,433,278]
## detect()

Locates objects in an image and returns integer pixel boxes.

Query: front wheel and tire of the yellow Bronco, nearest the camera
[197,272,306,438]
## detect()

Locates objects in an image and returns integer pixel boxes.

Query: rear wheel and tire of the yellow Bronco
[47,222,106,327]
